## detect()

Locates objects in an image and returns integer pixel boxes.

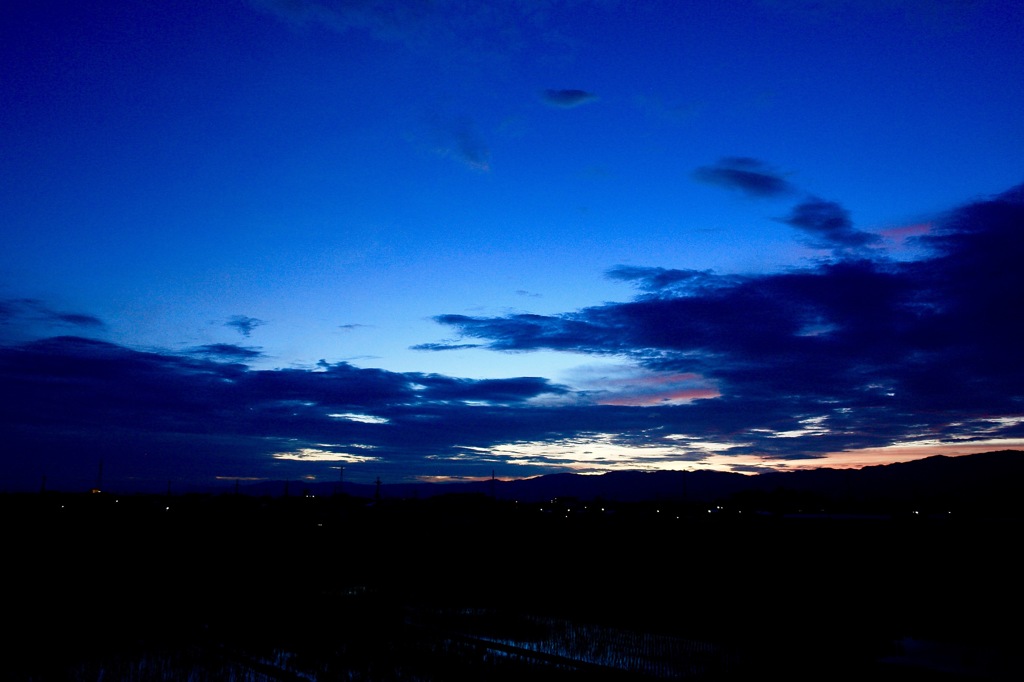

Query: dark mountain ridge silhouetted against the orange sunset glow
[241,450,1024,514]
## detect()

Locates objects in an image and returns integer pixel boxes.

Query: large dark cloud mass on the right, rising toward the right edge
[428,182,1024,458]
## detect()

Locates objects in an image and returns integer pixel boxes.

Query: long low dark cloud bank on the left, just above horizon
[0,337,565,489]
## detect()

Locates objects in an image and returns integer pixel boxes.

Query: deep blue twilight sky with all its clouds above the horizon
[0,0,1024,491]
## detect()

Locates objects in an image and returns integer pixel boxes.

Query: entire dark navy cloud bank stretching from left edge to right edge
[8,187,1024,489]
